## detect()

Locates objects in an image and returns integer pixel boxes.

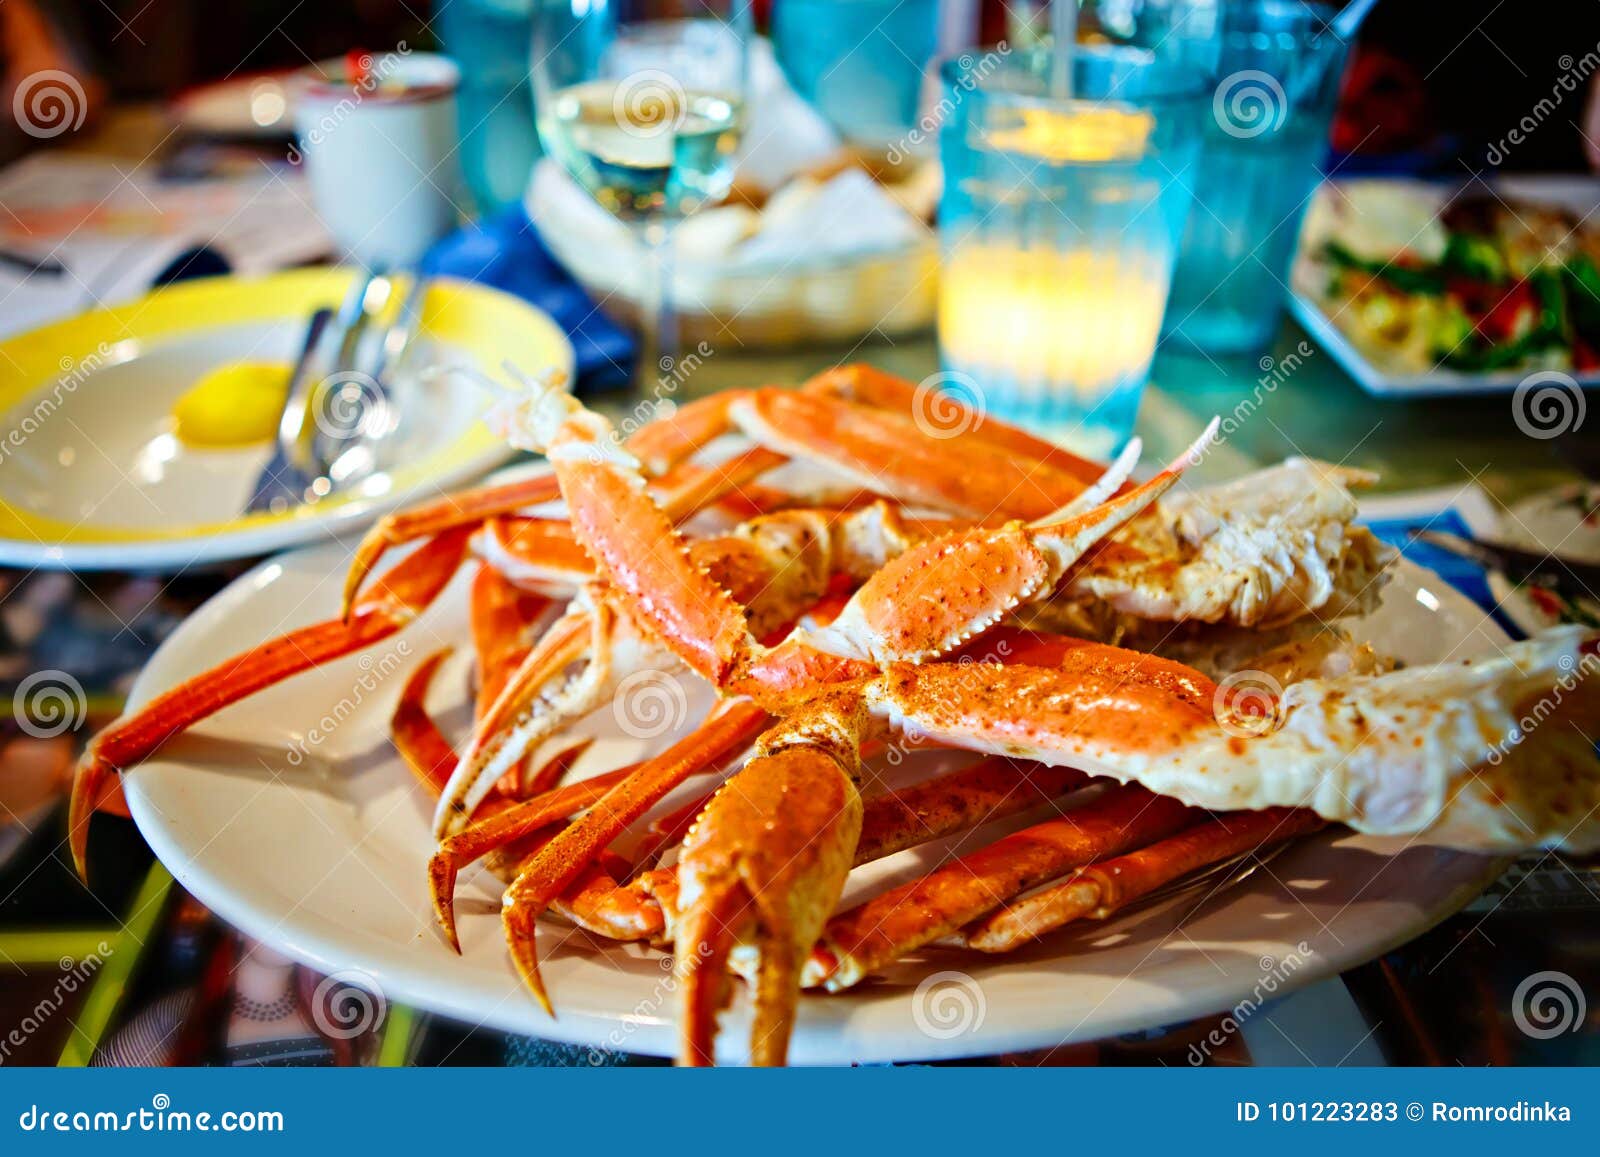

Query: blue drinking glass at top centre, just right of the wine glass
[771,0,939,147]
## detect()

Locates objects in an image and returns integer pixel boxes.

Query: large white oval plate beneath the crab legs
[126,546,1504,1064]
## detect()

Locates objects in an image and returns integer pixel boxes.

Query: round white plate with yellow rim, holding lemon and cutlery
[0,269,573,571]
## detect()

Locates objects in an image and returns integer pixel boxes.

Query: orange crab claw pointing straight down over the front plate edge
[674,746,861,1066]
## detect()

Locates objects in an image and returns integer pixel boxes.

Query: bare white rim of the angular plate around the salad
[1290,176,1600,397]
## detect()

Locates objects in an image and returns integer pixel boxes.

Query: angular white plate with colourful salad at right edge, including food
[1290,178,1600,397]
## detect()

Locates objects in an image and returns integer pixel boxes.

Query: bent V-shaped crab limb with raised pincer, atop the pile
[501,366,1216,696]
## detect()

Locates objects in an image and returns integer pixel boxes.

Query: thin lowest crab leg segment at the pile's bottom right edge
[960,808,1326,952]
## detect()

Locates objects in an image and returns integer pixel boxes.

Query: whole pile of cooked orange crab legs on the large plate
[74,368,1600,1063]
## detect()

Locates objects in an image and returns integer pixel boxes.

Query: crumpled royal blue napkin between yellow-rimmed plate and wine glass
[422,206,635,390]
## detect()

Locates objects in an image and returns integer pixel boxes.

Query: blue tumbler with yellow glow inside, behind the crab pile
[936,46,1210,454]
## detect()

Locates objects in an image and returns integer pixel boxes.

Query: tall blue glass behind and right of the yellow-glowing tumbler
[1166,0,1349,354]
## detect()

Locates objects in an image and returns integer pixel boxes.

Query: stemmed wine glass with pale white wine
[531,0,752,392]
